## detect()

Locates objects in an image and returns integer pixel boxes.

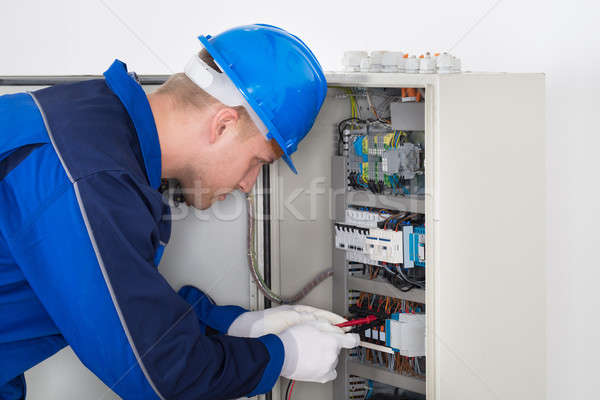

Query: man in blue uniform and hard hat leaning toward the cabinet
[0,25,358,399]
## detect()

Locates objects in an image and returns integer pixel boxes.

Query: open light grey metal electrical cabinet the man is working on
[257,73,546,400]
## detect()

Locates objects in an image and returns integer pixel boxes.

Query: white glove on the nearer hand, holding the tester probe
[278,321,360,383]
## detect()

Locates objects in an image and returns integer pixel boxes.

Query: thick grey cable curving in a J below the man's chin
[247,195,333,304]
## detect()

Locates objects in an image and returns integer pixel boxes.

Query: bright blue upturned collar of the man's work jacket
[104,60,161,189]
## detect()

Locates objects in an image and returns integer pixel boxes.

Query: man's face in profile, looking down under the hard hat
[179,109,282,210]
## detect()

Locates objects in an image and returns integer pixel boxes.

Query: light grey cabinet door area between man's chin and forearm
[159,192,250,308]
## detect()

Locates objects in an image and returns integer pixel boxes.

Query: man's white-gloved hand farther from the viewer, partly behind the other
[227,305,346,337]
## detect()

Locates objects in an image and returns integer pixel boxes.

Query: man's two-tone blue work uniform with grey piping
[0,60,284,400]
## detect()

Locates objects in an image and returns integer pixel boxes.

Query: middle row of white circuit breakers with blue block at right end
[335,206,425,268]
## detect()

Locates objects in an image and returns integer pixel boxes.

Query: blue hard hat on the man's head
[198,24,327,173]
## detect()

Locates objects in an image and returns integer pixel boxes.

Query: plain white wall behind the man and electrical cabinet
[0,0,600,399]
